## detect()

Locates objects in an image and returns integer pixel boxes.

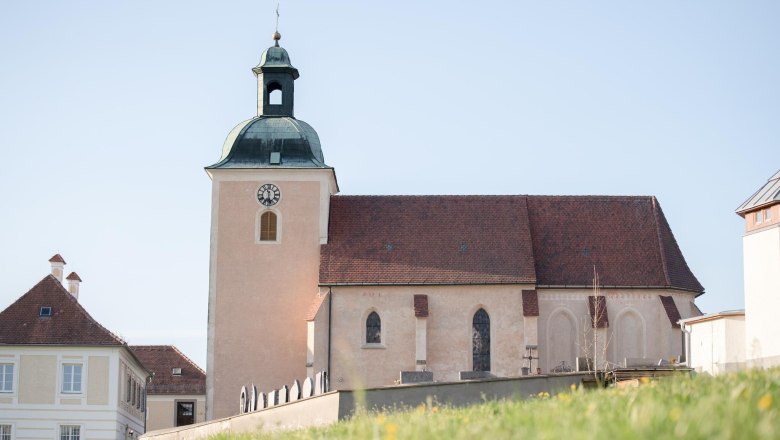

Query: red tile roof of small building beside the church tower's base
[130,345,206,394]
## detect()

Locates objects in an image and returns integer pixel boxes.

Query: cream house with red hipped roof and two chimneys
[0,254,150,440]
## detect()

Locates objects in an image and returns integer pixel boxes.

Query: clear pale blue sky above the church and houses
[0,0,780,367]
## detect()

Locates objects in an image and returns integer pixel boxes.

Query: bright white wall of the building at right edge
[743,225,780,366]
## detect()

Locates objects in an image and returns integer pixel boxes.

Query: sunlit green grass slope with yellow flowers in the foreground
[213,369,780,440]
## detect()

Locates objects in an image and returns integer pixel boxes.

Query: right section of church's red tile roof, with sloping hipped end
[528,196,704,292]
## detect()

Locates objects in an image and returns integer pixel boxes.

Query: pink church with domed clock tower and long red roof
[206,33,704,420]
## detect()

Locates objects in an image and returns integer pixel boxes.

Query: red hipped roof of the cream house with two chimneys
[0,275,125,346]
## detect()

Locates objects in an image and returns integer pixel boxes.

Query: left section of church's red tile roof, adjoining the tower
[320,196,535,285]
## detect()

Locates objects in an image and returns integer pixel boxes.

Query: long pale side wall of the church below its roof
[315,285,695,389]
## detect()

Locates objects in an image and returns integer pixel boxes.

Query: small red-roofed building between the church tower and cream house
[130,345,206,432]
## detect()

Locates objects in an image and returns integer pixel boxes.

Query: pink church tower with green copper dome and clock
[206,32,338,420]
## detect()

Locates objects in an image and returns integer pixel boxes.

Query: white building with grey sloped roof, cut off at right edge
[737,171,780,367]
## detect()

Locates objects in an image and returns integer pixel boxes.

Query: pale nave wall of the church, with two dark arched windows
[322,285,531,389]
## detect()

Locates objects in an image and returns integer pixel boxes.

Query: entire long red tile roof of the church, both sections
[320,196,704,292]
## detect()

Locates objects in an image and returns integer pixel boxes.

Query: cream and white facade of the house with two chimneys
[0,346,143,440]
